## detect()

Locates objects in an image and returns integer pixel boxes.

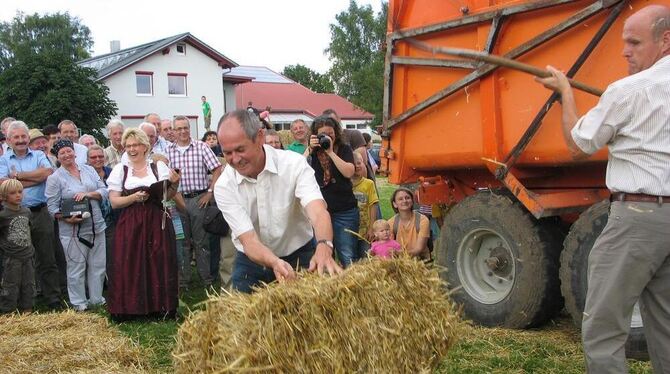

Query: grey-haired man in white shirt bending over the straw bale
[214,110,342,292]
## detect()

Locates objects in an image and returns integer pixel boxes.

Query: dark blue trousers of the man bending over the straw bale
[232,240,314,293]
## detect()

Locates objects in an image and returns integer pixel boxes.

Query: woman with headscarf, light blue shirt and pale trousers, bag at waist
[45,139,107,311]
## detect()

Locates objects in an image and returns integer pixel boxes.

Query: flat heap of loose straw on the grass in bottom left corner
[0,311,146,374]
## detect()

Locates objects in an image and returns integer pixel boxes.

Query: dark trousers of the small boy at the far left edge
[0,256,35,313]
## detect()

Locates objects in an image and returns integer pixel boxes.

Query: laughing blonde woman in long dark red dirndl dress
[107,128,179,321]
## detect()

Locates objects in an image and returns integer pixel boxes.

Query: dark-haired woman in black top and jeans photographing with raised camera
[309,116,361,267]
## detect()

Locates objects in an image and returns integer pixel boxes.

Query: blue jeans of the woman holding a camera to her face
[330,207,361,268]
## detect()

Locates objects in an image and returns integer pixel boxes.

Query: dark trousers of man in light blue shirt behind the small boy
[30,207,61,304]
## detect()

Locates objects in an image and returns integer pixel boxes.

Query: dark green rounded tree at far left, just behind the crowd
[0,52,117,137]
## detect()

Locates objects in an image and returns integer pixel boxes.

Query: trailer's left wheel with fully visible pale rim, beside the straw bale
[436,191,563,328]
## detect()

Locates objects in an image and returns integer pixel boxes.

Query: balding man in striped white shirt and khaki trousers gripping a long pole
[538,5,670,373]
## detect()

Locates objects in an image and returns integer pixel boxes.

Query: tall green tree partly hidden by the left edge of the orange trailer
[325,0,388,126]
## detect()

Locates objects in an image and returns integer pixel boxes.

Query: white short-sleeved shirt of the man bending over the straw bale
[214,145,323,257]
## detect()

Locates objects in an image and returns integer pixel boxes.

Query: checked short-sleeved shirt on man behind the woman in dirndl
[166,139,221,193]
